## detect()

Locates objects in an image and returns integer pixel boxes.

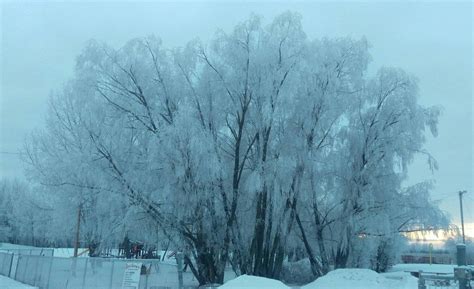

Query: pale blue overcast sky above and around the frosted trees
[0,1,474,231]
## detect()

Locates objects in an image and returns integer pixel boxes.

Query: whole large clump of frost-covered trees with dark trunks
[25,12,445,284]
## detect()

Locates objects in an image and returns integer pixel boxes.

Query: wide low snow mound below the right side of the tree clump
[301,269,417,289]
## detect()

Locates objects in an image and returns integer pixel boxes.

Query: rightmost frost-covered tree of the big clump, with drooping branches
[290,66,446,275]
